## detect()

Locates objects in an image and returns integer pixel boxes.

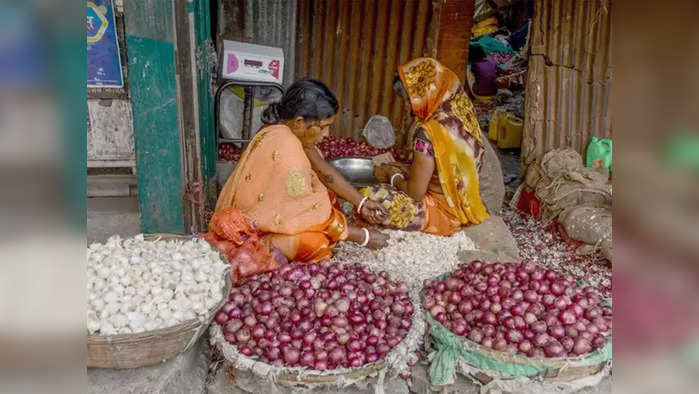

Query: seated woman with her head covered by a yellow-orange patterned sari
[370,58,488,235]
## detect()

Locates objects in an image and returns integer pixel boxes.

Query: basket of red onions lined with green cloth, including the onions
[423,261,612,384]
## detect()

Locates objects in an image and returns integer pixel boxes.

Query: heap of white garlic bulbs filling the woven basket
[87,234,228,335]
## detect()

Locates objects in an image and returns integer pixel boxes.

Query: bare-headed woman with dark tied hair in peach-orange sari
[216,79,387,262]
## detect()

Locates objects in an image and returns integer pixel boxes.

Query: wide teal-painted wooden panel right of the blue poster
[124,0,184,233]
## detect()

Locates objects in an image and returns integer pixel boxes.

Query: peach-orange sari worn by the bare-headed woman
[216,125,348,262]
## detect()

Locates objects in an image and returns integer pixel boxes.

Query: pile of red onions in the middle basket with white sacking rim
[215,261,413,371]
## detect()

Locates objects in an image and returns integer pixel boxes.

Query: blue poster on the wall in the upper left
[87,0,124,88]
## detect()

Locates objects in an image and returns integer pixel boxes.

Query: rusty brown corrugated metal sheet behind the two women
[295,0,432,138]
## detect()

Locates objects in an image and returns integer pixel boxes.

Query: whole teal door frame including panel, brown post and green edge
[124,0,216,234]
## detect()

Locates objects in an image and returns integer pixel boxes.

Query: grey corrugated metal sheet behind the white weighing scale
[216,0,296,86]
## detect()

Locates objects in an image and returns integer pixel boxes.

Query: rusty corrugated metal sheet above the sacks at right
[522,0,612,165]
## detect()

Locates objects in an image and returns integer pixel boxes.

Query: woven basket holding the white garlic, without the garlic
[87,234,232,369]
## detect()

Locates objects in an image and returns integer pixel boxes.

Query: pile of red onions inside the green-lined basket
[424,261,612,357]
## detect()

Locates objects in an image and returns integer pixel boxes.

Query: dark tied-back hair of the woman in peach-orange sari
[262,78,338,124]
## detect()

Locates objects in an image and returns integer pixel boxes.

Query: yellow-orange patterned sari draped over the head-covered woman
[361,58,488,235]
